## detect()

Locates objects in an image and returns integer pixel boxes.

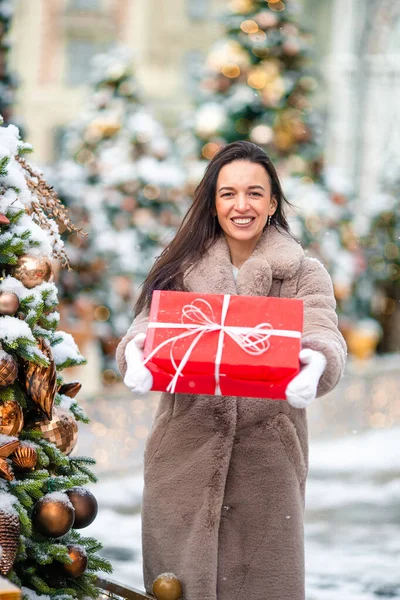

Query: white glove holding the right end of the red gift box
[286,348,326,408]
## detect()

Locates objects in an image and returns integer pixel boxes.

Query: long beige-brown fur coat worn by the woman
[117,227,346,600]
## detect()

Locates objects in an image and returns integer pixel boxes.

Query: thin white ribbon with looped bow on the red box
[143,294,301,396]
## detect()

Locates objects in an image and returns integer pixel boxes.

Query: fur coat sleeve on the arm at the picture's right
[296,258,347,397]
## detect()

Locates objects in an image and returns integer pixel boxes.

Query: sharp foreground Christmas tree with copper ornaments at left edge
[0,119,111,600]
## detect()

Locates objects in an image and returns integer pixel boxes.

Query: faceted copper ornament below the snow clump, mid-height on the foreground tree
[34,406,78,455]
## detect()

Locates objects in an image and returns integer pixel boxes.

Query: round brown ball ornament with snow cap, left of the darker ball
[32,492,75,538]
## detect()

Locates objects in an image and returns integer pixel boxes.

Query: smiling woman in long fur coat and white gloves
[117,142,346,600]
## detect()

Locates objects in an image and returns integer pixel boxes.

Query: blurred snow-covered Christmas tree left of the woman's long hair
[54,46,183,376]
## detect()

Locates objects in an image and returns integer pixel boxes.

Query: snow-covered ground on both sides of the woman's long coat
[86,428,400,600]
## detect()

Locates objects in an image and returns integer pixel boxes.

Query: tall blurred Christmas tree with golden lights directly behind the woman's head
[180,0,365,344]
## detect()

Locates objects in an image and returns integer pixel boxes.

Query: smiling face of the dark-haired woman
[215,160,277,242]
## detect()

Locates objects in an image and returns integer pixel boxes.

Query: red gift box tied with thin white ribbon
[144,291,303,400]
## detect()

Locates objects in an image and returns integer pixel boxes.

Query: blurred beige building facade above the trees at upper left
[11,0,226,163]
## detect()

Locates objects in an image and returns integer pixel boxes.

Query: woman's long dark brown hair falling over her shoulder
[135,141,290,315]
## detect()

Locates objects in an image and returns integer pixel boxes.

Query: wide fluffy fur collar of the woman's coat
[184,227,304,296]
